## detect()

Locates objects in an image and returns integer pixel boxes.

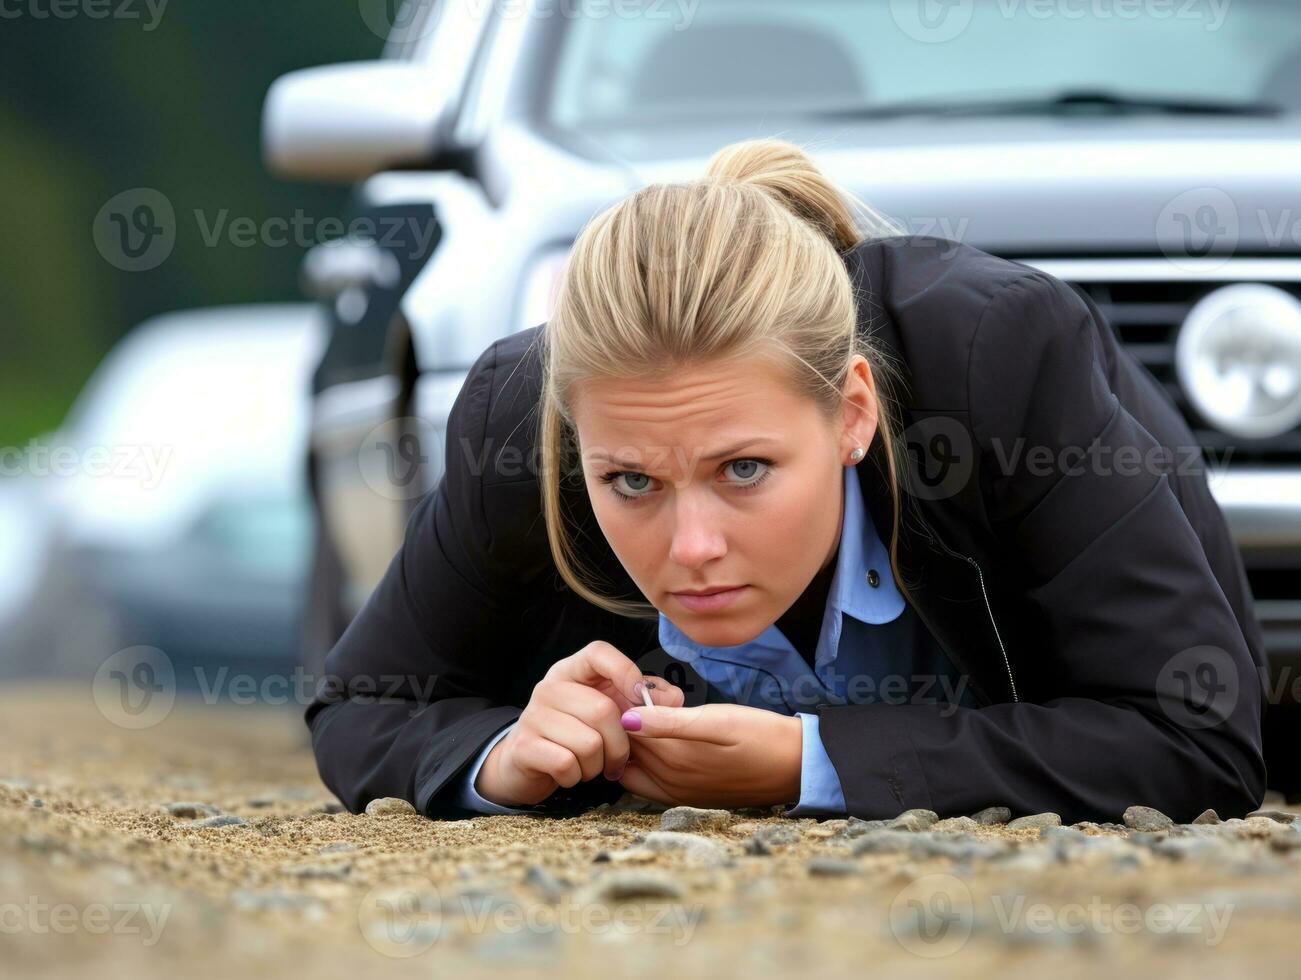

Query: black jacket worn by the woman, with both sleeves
[307,236,1266,821]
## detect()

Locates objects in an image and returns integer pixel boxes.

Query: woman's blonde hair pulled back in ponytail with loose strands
[539,139,909,618]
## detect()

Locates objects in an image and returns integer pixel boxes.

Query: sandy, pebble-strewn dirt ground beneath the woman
[0,686,1301,979]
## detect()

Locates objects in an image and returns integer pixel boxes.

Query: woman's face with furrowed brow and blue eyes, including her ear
[571,355,877,647]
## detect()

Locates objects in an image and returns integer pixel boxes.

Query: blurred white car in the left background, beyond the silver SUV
[0,303,324,683]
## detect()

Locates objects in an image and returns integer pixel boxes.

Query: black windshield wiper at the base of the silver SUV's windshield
[817,90,1284,120]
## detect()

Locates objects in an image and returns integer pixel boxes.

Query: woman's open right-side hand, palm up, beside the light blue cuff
[619,704,804,807]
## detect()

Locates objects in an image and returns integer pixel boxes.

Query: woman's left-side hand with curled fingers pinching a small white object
[475,640,684,807]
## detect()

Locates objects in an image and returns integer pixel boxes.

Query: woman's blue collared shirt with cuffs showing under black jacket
[458,466,977,816]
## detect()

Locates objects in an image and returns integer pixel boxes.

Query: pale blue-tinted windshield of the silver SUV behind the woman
[548,0,1301,128]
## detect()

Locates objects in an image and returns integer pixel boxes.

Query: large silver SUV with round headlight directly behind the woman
[264,0,1301,786]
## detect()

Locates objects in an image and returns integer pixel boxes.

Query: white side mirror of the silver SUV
[262,61,448,181]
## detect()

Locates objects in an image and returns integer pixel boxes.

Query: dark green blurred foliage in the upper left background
[0,0,382,446]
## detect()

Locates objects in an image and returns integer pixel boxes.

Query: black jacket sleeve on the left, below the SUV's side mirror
[306,344,622,817]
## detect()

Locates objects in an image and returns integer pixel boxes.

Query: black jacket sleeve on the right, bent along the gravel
[821,272,1265,821]
